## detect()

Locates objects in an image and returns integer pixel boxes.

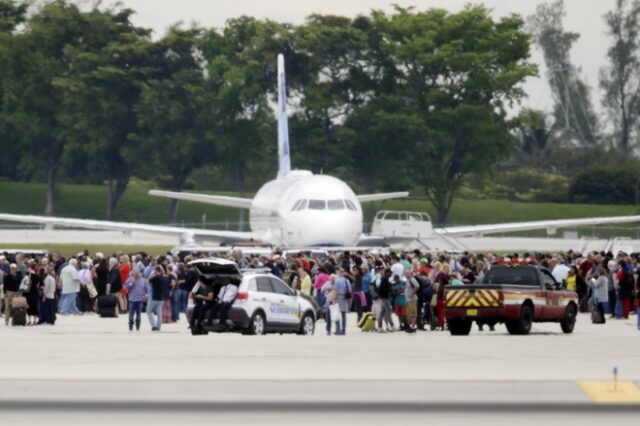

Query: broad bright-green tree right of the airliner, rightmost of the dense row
[364,6,536,224]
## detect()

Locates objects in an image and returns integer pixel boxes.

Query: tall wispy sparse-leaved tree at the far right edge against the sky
[600,0,640,150]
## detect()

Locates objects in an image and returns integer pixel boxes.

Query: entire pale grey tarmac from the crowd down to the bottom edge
[0,314,640,425]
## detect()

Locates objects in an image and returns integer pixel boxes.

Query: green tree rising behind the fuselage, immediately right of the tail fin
[287,15,371,178]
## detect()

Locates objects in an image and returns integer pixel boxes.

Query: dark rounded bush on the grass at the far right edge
[569,165,640,204]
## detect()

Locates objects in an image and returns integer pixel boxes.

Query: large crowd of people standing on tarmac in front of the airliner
[0,250,640,335]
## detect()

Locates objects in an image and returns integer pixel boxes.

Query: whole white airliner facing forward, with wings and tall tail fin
[0,55,640,248]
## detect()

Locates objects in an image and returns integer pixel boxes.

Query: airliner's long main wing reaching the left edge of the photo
[0,213,261,243]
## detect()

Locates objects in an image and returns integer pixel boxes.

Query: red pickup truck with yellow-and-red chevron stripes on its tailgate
[445,266,578,335]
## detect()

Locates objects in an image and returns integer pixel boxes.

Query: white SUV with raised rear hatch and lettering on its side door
[189,258,316,335]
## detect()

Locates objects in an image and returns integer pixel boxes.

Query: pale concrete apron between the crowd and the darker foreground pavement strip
[0,315,640,381]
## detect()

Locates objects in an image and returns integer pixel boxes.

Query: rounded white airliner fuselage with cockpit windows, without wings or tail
[250,170,362,247]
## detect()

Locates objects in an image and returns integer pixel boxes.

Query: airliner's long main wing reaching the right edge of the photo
[434,216,640,237]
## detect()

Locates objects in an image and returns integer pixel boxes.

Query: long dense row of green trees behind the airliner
[0,0,536,222]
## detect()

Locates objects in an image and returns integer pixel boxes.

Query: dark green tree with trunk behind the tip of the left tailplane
[137,27,217,222]
